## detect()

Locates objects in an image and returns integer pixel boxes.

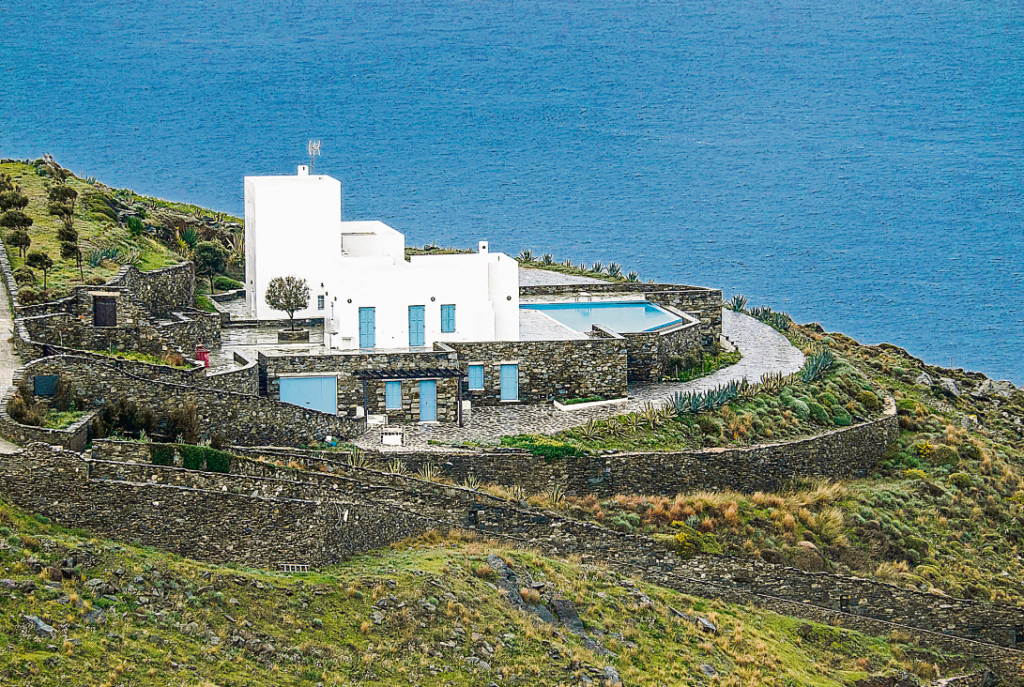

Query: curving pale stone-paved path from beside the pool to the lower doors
[356,310,804,450]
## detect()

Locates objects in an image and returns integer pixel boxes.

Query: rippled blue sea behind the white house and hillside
[0,0,1024,384]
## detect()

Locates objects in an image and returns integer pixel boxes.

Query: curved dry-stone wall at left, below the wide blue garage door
[25,355,362,445]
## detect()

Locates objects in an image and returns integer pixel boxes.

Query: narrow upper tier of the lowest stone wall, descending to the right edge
[77,440,1024,656]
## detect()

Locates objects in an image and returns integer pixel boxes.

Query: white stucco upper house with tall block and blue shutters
[245,167,519,349]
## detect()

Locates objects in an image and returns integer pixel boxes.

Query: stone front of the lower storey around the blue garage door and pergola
[259,350,458,422]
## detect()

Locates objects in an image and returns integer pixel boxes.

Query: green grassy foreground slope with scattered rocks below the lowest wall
[0,503,968,687]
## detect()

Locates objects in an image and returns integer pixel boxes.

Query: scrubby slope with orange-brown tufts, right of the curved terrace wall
[541,329,1024,605]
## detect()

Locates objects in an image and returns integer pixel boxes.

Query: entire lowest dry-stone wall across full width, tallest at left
[0,444,1024,678]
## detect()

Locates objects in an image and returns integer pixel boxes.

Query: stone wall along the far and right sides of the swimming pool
[519,282,722,346]
